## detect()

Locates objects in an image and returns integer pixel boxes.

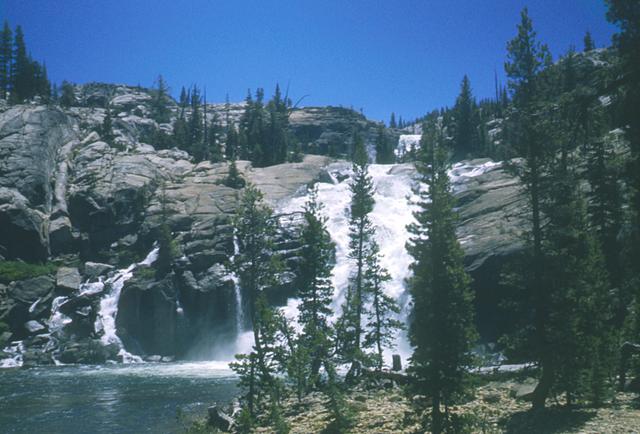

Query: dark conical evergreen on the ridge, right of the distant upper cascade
[453,75,478,160]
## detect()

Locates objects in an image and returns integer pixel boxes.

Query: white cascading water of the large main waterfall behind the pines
[278,159,501,363]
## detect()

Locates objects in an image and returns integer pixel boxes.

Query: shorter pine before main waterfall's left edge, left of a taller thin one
[297,189,335,384]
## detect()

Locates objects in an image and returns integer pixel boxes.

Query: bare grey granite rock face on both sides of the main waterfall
[0,83,526,363]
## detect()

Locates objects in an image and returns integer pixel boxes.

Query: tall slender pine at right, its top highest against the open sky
[505,8,555,408]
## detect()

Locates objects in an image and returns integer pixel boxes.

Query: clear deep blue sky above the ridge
[0,0,615,120]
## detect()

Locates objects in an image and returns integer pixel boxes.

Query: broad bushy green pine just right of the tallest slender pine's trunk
[543,161,614,404]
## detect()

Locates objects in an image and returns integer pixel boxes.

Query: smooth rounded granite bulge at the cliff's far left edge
[0,106,76,261]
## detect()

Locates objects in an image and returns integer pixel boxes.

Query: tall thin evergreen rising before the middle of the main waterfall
[337,140,374,381]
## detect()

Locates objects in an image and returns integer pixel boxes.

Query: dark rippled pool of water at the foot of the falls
[0,362,238,434]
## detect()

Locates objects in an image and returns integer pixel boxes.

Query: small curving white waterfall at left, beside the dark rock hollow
[95,247,159,363]
